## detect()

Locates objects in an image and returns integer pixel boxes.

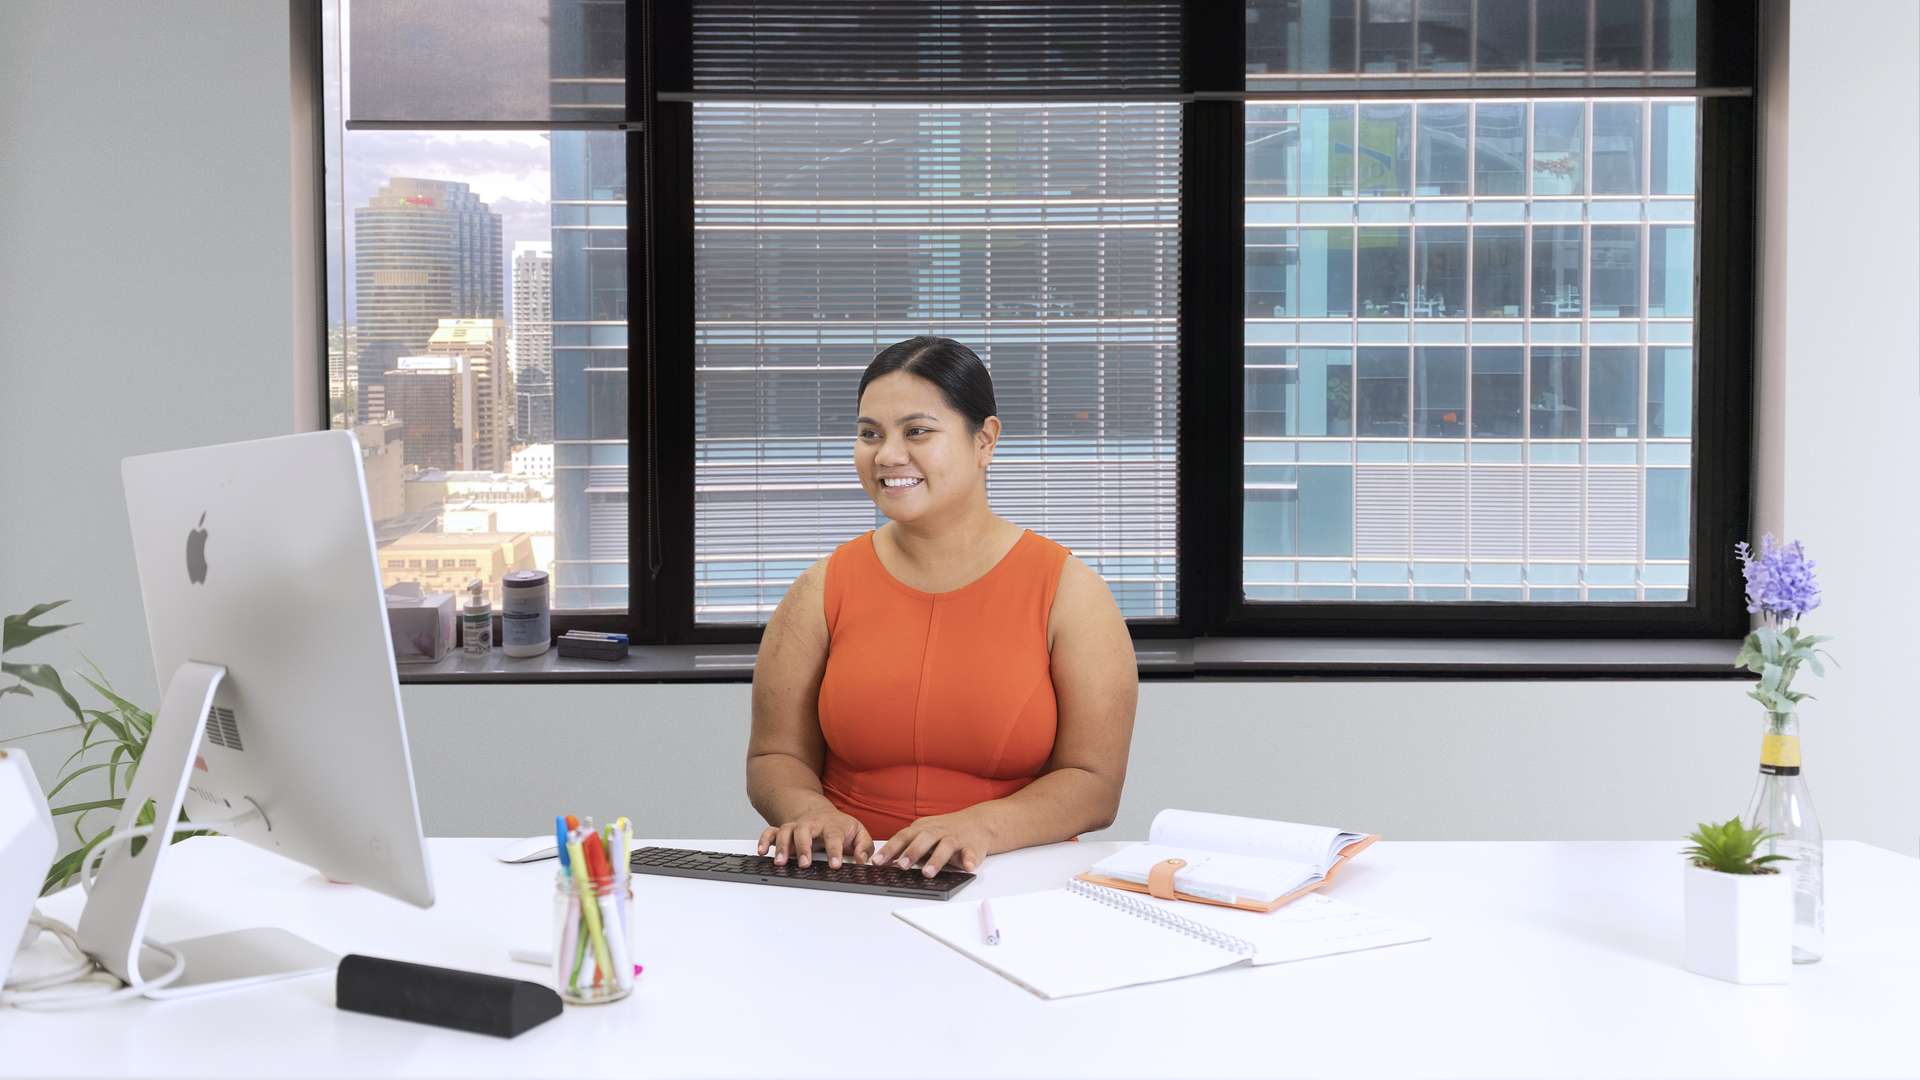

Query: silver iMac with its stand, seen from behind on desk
[81,430,434,992]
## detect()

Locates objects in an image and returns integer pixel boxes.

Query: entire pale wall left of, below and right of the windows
[0,0,1920,853]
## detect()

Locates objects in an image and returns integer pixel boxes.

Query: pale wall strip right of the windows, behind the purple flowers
[1757,0,1920,853]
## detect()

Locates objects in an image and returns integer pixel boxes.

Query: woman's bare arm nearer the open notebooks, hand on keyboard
[876,557,1140,876]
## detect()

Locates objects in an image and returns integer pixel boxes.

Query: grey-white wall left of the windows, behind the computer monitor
[0,0,303,807]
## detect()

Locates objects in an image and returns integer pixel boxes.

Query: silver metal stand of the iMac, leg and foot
[77,661,340,997]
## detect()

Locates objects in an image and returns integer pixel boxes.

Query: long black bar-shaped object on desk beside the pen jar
[334,953,561,1040]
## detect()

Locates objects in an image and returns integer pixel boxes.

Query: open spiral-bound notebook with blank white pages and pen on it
[895,880,1427,999]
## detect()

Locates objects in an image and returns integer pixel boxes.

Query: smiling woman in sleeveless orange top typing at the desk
[747,338,1139,876]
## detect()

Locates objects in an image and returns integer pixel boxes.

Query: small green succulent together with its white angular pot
[1680,817,1793,982]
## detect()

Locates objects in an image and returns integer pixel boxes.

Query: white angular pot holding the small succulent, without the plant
[1686,863,1793,982]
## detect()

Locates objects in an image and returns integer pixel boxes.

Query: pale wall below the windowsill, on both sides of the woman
[403,682,1766,849]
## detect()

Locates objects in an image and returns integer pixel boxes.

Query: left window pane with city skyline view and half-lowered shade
[323,0,628,611]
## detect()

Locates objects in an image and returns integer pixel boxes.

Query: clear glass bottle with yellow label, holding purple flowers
[1745,713,1826,963]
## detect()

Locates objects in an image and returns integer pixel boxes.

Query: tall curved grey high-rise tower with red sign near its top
[353,177,503,421]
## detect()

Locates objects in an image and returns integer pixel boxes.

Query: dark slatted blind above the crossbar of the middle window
[693,0,1183,100]
